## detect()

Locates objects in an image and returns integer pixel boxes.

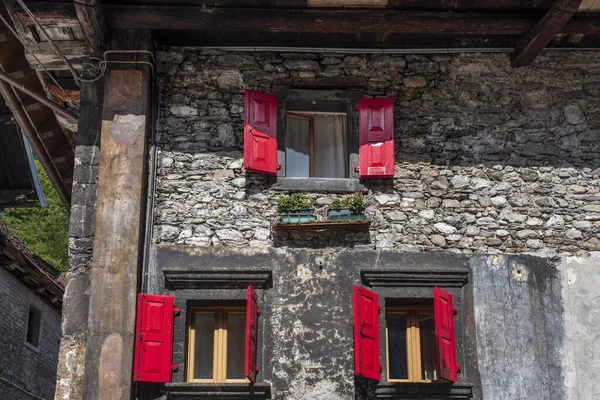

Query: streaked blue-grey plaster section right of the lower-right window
[471,255,564,400]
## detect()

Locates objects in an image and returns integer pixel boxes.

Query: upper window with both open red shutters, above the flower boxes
[244,89,394,178]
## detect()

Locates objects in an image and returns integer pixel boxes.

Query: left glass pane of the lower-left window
[194,313,215,379]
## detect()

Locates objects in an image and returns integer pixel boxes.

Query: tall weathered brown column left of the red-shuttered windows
[84,31,152,400]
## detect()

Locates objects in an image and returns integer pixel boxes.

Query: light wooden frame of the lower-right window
[385,305,437,383]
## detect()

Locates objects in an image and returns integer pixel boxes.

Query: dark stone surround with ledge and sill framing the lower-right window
[360,265,474,400]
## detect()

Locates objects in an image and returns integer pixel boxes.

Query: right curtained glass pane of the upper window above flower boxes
[314,114,348,178]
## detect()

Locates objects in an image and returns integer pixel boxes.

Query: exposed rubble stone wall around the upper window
[154,48,600,257]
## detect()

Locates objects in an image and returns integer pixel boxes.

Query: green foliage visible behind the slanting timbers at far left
[0,160,69,272]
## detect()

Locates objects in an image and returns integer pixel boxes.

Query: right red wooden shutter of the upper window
[358,98,394,178]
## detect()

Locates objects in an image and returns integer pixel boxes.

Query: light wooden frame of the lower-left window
[186,306,250,383]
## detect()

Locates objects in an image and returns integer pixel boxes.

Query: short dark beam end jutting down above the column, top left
[74,0,108,53]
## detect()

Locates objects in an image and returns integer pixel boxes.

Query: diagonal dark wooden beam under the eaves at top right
[510,0,582,67]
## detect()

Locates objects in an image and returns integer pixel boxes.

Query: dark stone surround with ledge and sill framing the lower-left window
[163,268,272,400]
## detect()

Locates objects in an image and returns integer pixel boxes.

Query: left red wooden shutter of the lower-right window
[354,286,381,382]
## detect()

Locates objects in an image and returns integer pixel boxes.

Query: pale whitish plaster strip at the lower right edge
[560,253,600,400]
